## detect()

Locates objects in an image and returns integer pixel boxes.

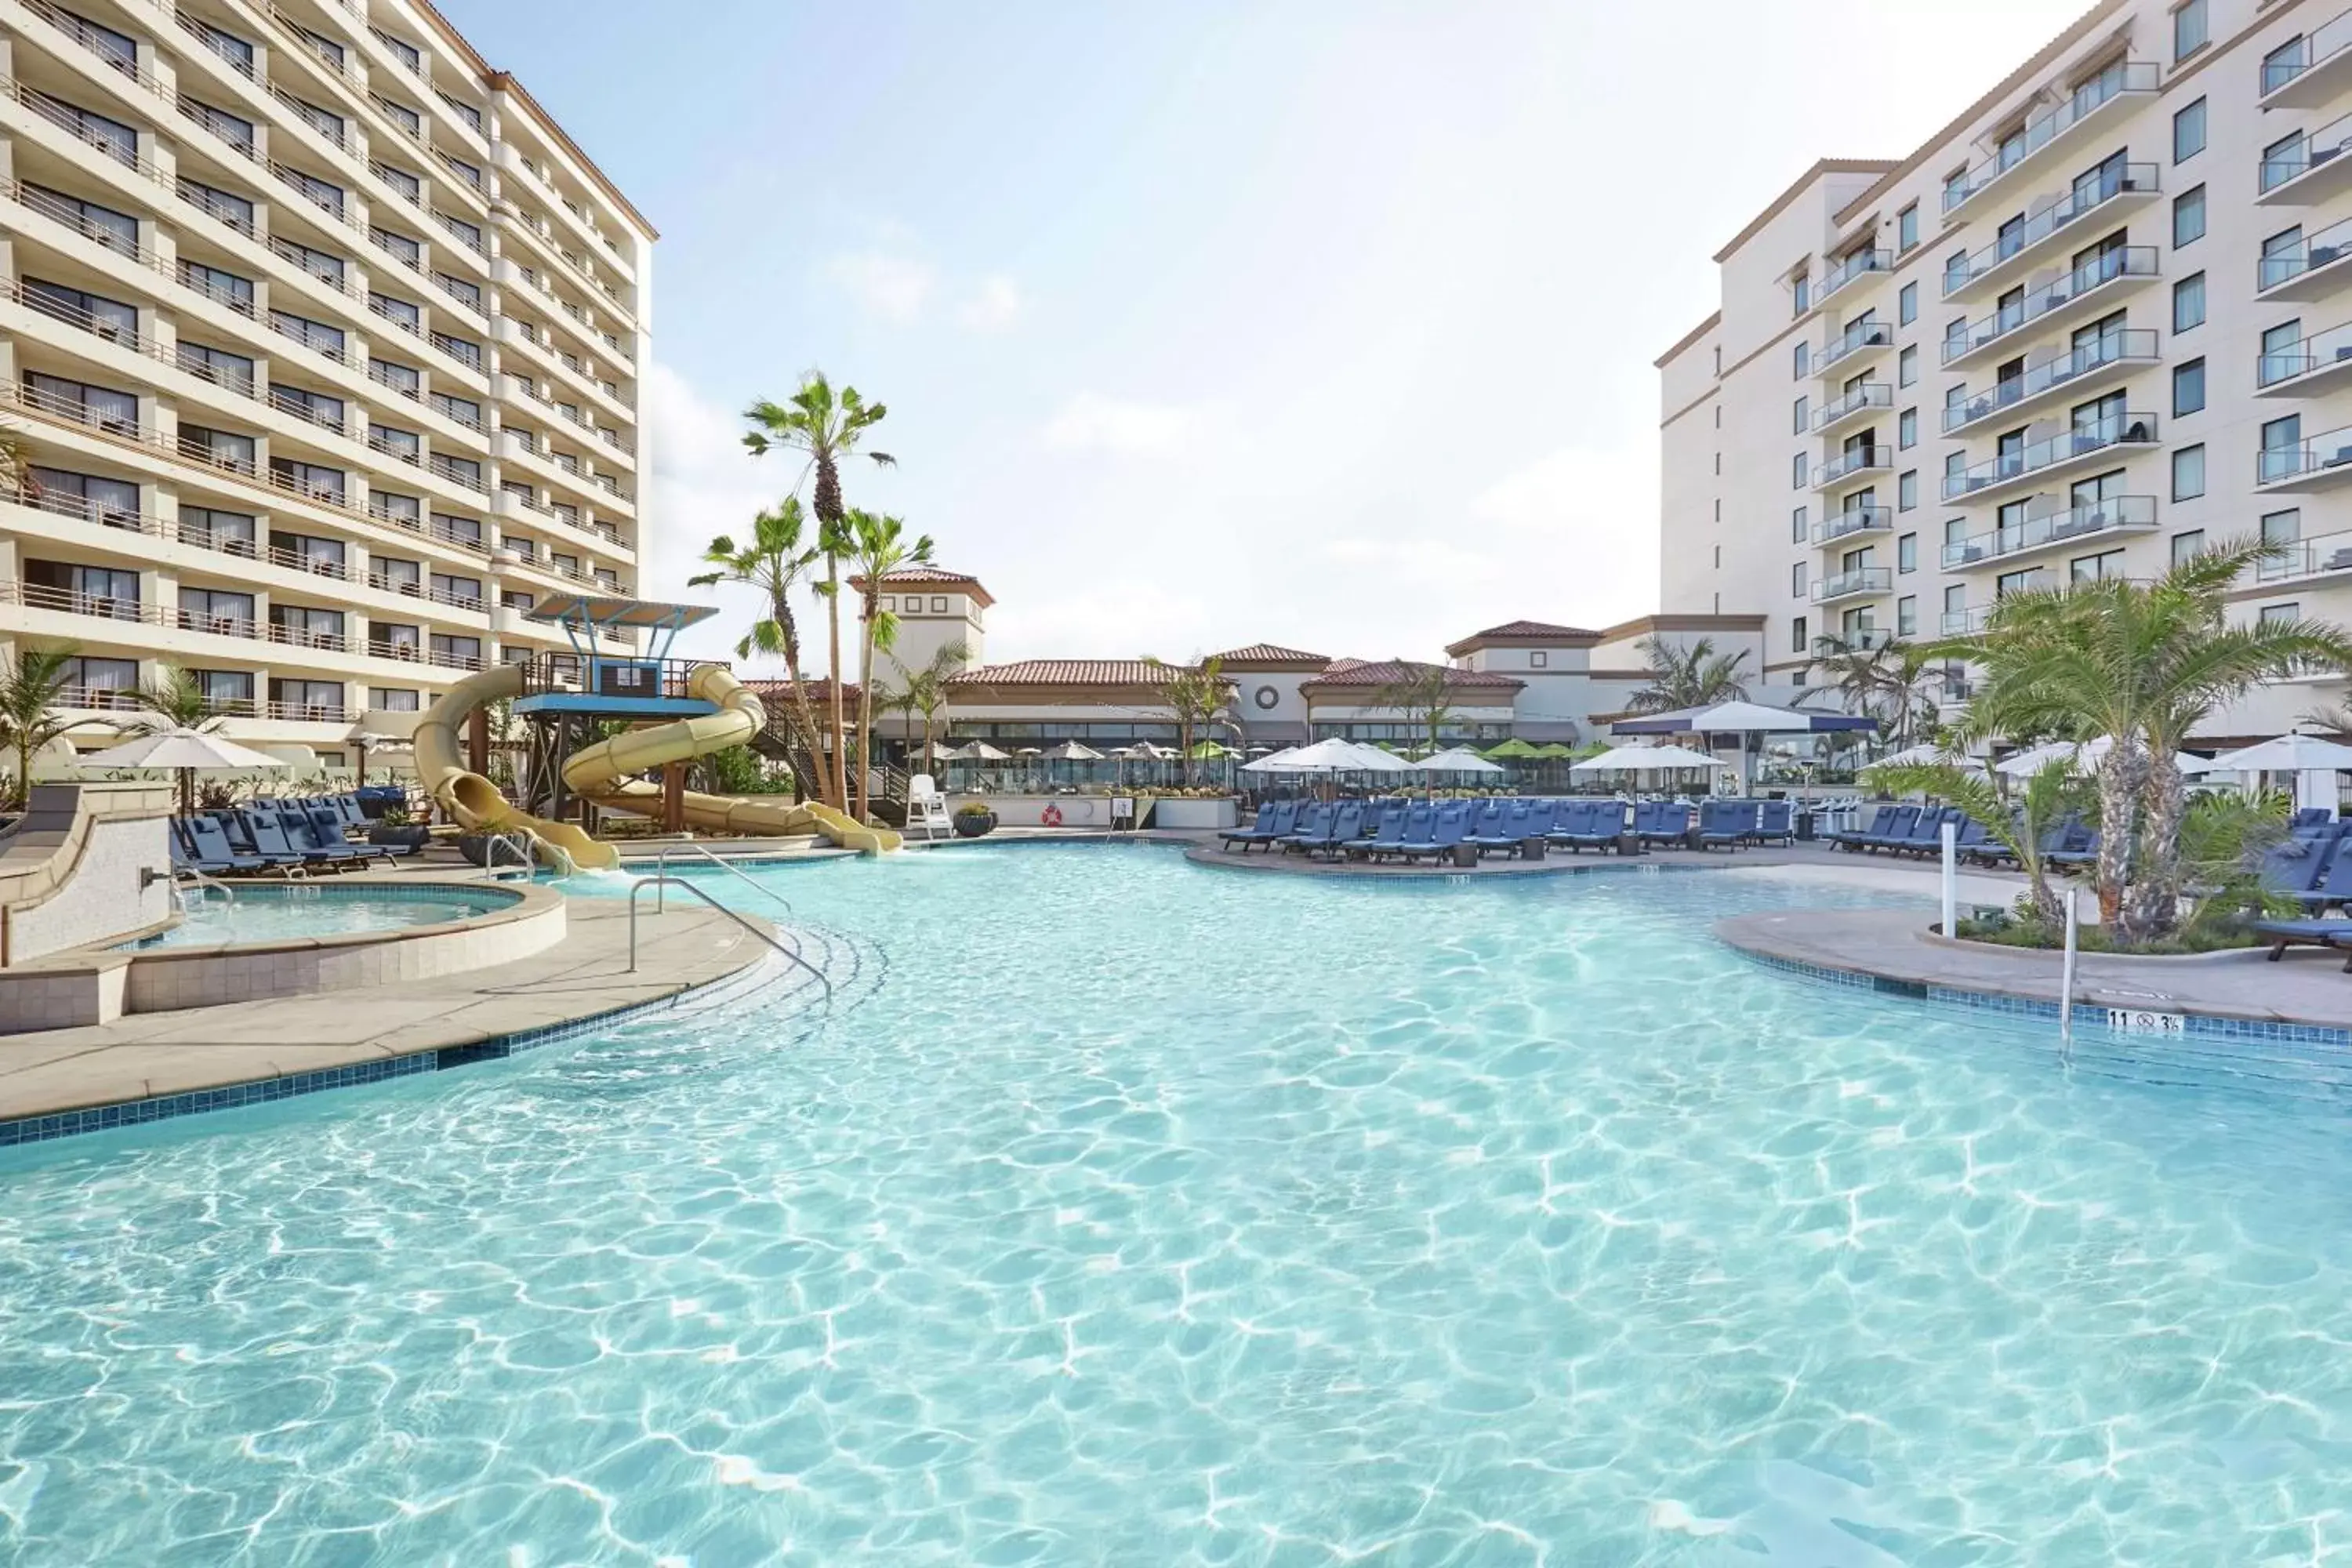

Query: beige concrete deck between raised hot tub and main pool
[0,888,769,1121]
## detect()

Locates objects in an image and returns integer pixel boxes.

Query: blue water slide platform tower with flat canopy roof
[515,593,720,820]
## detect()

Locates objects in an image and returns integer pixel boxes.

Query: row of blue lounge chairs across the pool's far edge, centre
[1218,797,1795,862]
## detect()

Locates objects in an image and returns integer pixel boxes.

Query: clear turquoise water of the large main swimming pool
[0,848,2352,1568]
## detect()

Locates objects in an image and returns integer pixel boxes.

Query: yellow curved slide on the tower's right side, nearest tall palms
[564,666,901,853]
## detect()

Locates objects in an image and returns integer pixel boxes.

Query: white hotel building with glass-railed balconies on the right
[1658,0,2352,741]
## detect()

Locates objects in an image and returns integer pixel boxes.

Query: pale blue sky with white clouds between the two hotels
[440,0,2089,663]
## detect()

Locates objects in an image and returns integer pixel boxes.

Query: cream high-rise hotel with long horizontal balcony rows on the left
[0,0,654,762]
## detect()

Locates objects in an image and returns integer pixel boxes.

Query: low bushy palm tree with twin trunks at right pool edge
[1936,539,2352,945]
